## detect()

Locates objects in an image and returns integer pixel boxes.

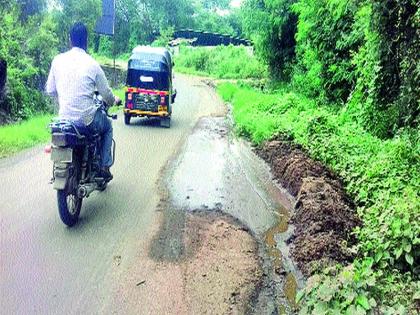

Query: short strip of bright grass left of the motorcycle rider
[0,114,52,158]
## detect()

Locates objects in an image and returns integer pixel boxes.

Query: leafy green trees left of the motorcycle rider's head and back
[0,5,57,118]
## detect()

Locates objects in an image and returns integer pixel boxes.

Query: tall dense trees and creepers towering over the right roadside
[243,0,420,137]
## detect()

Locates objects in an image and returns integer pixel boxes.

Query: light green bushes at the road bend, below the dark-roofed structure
[175,46,267,79]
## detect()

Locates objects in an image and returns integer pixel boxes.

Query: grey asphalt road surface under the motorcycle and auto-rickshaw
[0,75,224,314]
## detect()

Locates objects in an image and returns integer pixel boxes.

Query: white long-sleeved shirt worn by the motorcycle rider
[45,47,114,125]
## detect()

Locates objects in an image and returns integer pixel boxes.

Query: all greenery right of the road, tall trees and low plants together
[215,0,420,314]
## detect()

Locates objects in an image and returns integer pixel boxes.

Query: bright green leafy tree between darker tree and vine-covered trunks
[292,0,362,103]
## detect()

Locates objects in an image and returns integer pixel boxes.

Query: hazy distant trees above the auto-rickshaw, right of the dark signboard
[95,0,242,56]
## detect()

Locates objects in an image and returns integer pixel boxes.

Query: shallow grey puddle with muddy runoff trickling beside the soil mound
[163,117,303,314]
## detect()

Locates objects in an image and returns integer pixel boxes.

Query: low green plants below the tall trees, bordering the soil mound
[217,83,420,314]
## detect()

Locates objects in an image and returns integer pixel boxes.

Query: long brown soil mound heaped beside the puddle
[257,140,360,275]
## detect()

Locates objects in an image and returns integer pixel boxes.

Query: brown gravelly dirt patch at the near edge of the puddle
[184,212,262,314]
